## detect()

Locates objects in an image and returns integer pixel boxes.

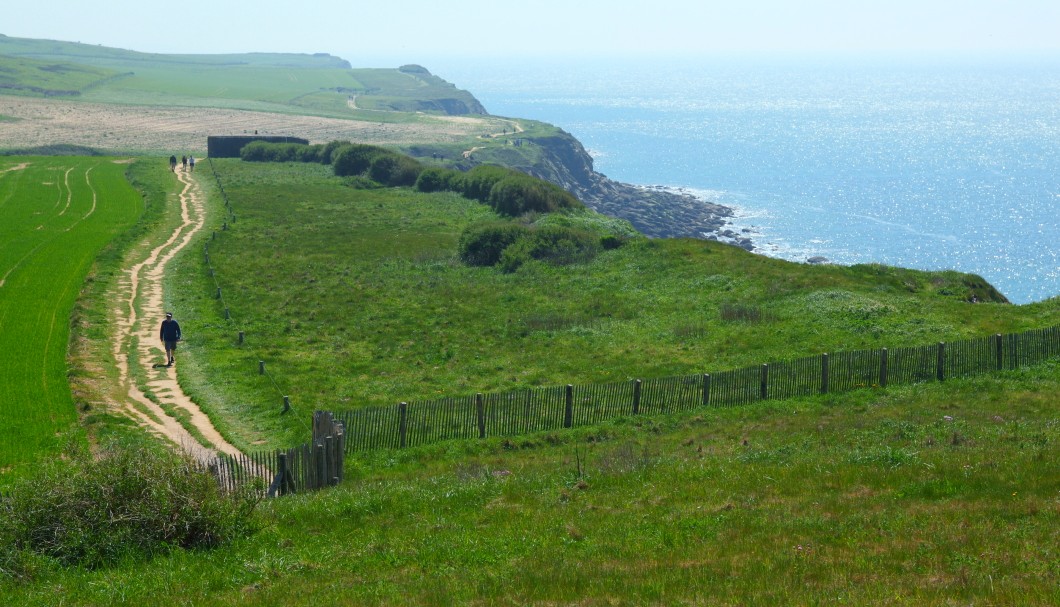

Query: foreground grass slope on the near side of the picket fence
[0,363,1060,607]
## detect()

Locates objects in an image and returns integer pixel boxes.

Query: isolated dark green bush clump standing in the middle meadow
[460,221,602,272]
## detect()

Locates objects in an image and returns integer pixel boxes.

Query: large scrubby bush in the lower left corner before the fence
[0,447,260,577]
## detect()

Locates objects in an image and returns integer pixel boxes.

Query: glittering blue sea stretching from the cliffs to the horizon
[427,56,1060,303]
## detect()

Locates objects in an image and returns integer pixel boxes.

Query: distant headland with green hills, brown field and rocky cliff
[0,35,753,241]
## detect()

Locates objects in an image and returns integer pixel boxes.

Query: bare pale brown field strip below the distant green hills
[0,95,509,156]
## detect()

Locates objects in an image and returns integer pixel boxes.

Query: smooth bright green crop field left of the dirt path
[0,157,142,468]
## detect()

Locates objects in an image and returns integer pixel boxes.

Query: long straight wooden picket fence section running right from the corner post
[335,326,1060,451]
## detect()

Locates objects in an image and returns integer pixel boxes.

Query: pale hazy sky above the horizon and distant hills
[0,0,1060,65]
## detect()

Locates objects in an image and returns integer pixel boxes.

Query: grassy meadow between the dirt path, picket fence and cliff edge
[169,160,1060,447]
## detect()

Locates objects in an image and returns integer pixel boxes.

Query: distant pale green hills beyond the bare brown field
[0,36,480,122]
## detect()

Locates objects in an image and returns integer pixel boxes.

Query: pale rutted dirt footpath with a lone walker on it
[111,172,240,461]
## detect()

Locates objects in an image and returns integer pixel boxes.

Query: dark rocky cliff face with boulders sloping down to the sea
[472,129,753,244]
